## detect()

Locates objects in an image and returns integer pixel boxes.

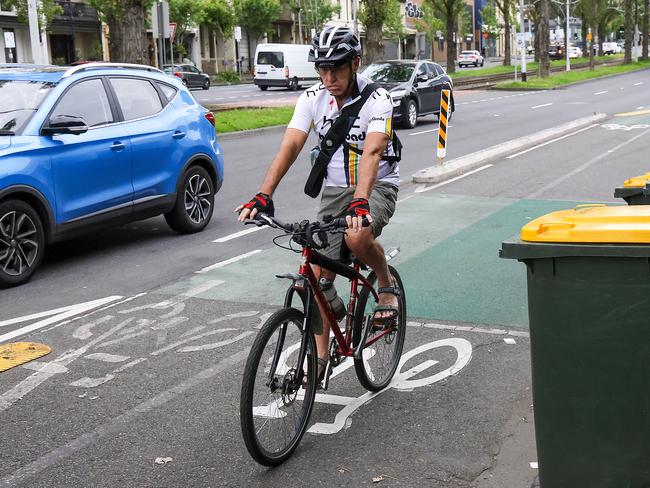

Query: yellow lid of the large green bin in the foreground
[521,205,650,244]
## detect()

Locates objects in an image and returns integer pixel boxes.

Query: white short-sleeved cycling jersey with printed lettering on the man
[289,75,399,187]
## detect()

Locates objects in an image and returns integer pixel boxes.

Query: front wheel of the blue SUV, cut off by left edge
[0,200,45,286]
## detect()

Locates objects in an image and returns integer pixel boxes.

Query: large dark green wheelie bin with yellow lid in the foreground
[500,205,650,488]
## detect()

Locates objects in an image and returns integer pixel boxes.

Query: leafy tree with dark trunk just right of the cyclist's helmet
[359,0,403,64]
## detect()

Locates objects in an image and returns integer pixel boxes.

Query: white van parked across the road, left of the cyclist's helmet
[253,44,319,90]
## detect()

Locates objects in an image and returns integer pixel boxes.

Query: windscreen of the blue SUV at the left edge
[0,80,56,133]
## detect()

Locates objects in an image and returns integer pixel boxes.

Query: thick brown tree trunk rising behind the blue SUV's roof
[106,0,149,64]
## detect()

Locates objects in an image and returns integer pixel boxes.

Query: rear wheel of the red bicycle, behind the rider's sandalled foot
[352,266,406,391]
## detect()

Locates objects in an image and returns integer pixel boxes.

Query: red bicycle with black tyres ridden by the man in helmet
[240,214,406,466]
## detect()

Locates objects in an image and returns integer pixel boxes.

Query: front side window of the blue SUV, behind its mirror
[50,78,115,127]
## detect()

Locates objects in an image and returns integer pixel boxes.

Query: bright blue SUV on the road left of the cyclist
[0,63,224,286]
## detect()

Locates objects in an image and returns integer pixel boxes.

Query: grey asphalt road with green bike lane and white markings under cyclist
[0,71,650,488]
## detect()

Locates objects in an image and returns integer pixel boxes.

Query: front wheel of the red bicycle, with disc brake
[239,308,317,466]
